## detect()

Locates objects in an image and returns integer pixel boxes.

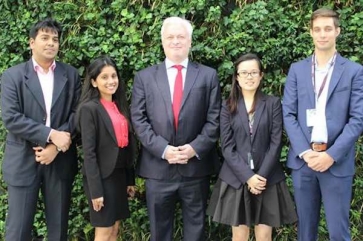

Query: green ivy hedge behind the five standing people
[0,0,363,241]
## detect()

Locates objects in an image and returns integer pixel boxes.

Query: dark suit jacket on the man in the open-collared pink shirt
[1,60,81,186]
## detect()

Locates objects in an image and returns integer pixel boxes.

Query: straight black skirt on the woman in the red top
[83,168,130,227]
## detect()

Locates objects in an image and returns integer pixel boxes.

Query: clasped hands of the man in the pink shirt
[33,130,72,165]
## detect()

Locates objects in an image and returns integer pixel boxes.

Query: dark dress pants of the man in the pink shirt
[5,162,74,241]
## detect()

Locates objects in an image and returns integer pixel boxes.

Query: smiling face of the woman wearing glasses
[237,59,263,93]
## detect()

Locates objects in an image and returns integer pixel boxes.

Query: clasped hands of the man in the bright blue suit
[302,150,334,172]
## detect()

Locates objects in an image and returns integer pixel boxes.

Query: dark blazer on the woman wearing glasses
[219,94,285,189]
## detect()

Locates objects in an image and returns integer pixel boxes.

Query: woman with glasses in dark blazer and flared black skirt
[207,54,297,241]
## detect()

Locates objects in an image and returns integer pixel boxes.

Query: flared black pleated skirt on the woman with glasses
[207,179,297,227]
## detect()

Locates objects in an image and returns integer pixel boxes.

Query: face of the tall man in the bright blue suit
[310,17,340,51]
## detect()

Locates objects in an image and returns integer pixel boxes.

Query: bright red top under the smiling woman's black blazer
[100,99,129,148]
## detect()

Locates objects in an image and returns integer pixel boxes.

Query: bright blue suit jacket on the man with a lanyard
[283,54,363,176]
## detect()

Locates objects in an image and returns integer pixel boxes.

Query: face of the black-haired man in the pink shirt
[30,29,59,63]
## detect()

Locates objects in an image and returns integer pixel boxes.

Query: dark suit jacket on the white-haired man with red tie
[131,62,221,179]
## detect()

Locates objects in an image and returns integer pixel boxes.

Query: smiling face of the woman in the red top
[92,65,118,101]
